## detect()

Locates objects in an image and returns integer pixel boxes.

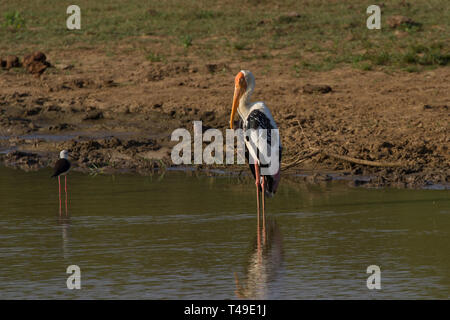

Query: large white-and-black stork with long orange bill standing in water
[230,70,282,222]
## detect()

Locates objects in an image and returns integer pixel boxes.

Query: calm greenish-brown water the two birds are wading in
[0,168,450,299]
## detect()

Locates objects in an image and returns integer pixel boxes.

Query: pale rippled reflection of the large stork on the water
[234,217,283,299]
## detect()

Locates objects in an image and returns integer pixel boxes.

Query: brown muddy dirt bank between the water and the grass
[0,50,450,188]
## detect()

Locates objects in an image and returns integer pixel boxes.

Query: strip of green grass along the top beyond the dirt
[0,0,450,72]
